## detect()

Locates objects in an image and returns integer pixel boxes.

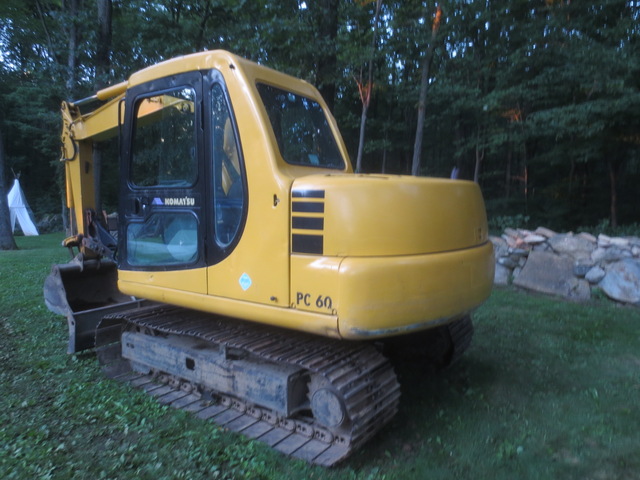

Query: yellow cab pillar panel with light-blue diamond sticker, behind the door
[205,52,292,306]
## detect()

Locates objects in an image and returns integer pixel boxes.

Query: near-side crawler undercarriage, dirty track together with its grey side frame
[96,305,400,466]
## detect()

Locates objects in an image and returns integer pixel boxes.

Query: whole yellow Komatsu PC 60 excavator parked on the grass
[44,51,494,465]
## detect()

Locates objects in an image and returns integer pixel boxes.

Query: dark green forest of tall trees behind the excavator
[0,0,640,231]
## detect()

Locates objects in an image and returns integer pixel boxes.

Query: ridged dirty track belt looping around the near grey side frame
[96,305,400,466]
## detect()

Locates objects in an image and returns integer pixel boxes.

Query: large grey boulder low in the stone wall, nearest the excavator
[513,251,589,300]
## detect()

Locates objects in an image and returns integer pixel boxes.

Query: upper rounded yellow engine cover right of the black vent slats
[293,175,488,256]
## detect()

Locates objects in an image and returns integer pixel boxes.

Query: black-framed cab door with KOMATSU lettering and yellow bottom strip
[119,72,209,296]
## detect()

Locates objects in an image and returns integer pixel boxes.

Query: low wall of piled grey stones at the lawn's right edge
[490,227,640,307]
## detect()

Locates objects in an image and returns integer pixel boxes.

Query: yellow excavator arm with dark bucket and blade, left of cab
[44,82,154,353]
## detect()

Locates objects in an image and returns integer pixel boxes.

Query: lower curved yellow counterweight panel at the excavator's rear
[338,242,494,339]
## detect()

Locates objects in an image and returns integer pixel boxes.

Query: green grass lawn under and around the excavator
[0,235,640,480]
